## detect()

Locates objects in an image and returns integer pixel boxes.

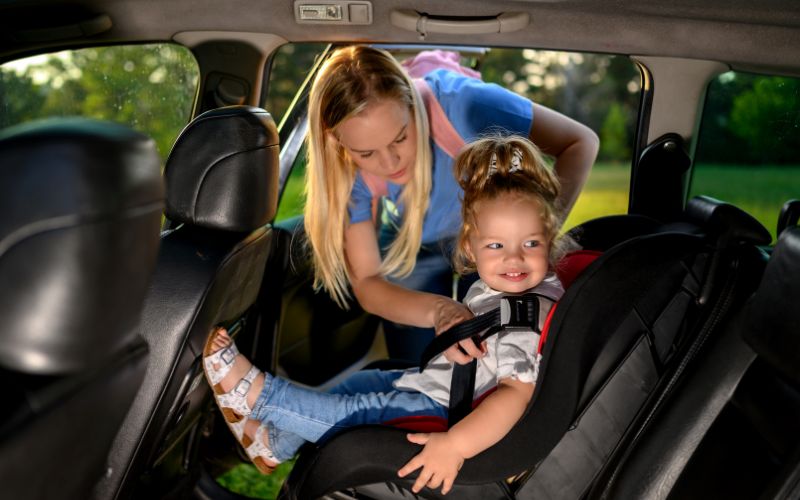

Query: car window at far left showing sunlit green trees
[0,43,199,164]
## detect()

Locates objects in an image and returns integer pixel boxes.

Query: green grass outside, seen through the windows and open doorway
[218,159,800,499]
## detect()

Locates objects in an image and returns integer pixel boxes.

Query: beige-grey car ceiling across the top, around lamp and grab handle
[0,0,800,74]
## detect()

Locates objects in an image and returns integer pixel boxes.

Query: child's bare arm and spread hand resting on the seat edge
[397,378,533,494]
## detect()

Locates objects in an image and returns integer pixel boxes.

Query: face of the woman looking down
[337,99,417,184]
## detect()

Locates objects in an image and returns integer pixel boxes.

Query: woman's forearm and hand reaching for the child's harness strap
[344,221,482,362]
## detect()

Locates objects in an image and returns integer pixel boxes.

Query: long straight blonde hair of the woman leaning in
[304,46,432,308]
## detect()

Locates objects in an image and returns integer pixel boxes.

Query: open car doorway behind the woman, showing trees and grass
[270,44,641,229]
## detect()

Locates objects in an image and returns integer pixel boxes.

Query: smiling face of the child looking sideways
[467,196,549,293]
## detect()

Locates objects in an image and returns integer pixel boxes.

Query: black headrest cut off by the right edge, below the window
[744,227,800,386]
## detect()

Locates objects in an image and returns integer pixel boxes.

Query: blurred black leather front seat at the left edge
[0,118,164,499]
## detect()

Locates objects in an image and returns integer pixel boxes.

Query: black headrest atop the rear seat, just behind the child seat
[686,196,772,245]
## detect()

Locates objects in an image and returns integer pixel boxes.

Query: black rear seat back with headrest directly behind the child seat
[517,197,770,499]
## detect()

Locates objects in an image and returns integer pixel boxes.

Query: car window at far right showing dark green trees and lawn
[689,71,800,242]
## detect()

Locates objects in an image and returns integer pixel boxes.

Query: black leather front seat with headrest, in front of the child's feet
[96,106,279,498]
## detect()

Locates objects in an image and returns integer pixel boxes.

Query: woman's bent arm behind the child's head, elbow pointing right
[530,103,600,219]
